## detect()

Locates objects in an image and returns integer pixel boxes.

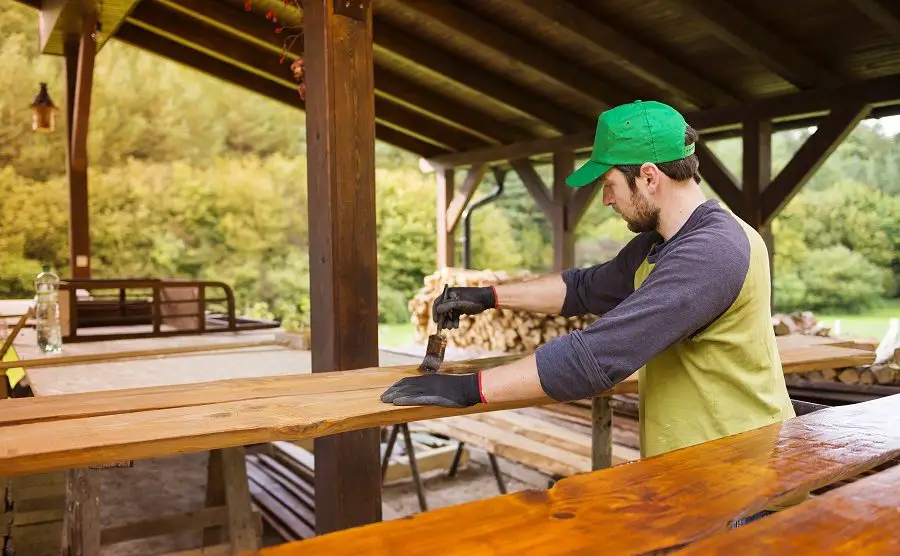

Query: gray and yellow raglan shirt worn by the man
[535,199,794,457]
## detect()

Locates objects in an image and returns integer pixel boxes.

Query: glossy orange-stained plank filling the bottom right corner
[678,466,900,556]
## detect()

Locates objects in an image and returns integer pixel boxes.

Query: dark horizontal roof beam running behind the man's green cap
[429,75,900,167]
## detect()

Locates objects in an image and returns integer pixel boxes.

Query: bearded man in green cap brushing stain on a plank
[382,101,794,457]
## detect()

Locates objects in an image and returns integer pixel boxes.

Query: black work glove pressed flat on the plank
[381,373,481,407]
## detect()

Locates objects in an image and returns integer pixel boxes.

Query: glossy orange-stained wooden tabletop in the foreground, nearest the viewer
[251,394,900,556]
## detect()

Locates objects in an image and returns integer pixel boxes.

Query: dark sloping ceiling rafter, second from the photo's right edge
[670,0,840,89]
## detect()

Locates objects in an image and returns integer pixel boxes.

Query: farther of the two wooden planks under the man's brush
[0,346,874,427]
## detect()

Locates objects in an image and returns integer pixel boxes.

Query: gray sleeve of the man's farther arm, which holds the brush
[560,234,652,317]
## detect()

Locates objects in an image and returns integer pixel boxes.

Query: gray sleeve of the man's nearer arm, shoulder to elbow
[535,229,750,401]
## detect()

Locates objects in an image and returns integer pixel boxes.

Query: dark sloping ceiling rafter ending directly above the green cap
[502,0,737,108]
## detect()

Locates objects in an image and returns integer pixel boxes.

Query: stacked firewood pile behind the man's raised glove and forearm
[409,268,597,353]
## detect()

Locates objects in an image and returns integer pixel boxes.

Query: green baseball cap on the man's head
[566,100,694,187]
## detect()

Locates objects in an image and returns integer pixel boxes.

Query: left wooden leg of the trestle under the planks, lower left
[63,469,100,556]
